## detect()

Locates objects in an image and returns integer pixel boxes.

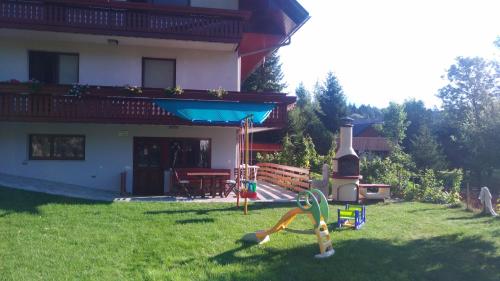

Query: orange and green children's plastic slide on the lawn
[243,189,335,258]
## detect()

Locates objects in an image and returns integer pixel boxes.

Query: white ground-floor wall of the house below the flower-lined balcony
[0,122,237,191]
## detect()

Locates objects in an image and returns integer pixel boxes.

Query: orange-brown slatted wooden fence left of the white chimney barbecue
[257,163,310,192]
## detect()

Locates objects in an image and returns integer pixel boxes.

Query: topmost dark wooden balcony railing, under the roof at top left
[0,0,249,43]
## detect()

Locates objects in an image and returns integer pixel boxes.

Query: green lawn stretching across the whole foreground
[0,188,500,281]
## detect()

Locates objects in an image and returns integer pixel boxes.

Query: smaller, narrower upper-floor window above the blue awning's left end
[142,58,175,88]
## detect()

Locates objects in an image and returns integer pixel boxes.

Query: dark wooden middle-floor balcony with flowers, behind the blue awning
[0,83,295,128]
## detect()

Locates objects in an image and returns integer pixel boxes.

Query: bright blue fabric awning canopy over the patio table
[154,100,276,125]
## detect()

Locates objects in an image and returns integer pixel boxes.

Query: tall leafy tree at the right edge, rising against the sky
[438,57,500,179]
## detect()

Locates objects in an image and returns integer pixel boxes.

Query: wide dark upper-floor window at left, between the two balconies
[28,51,79,84]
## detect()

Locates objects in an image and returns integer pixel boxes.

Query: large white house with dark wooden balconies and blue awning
[0,0,309,195]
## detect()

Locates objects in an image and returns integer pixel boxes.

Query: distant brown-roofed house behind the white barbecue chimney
[352,122,391,157]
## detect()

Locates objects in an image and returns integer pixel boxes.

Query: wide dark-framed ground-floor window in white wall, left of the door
[29,135,85,160]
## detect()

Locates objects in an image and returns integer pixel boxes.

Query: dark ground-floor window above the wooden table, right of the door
[169,139,211,168]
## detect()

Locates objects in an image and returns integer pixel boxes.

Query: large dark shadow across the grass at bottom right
[211,235,500,281]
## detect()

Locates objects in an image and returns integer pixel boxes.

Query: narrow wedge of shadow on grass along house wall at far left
[0,187,111,215]
